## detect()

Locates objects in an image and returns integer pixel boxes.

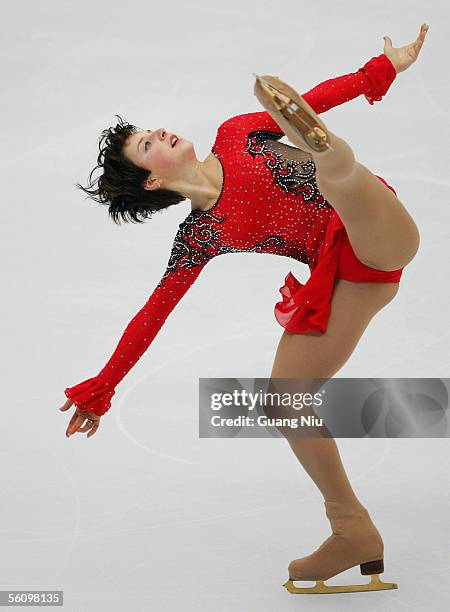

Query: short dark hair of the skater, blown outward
[76,115,186,225]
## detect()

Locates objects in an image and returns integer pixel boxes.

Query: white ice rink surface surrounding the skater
[0,0,450,612]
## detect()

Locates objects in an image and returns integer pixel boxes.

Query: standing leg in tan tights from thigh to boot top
[271,279,398,505]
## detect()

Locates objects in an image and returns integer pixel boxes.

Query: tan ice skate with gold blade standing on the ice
[283,501,398,593]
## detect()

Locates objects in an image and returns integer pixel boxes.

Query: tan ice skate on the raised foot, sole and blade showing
[253,73,334,153]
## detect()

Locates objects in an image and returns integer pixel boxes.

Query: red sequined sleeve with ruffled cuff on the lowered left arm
[64,226,209,416]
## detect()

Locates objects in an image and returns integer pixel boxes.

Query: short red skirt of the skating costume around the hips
[274,175,403,334]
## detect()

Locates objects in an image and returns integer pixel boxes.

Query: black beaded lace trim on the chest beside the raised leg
[246,130,333,209]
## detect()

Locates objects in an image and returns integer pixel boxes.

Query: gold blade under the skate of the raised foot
[252,72,334,153]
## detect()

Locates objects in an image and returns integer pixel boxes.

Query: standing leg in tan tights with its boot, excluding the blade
[271,279,398,580]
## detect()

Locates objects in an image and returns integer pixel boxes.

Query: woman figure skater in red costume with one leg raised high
[61,24,428,592]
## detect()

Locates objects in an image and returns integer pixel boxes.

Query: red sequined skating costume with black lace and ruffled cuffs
[64,54,402,415]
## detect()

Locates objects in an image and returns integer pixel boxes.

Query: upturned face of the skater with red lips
[123,128,195,189]
